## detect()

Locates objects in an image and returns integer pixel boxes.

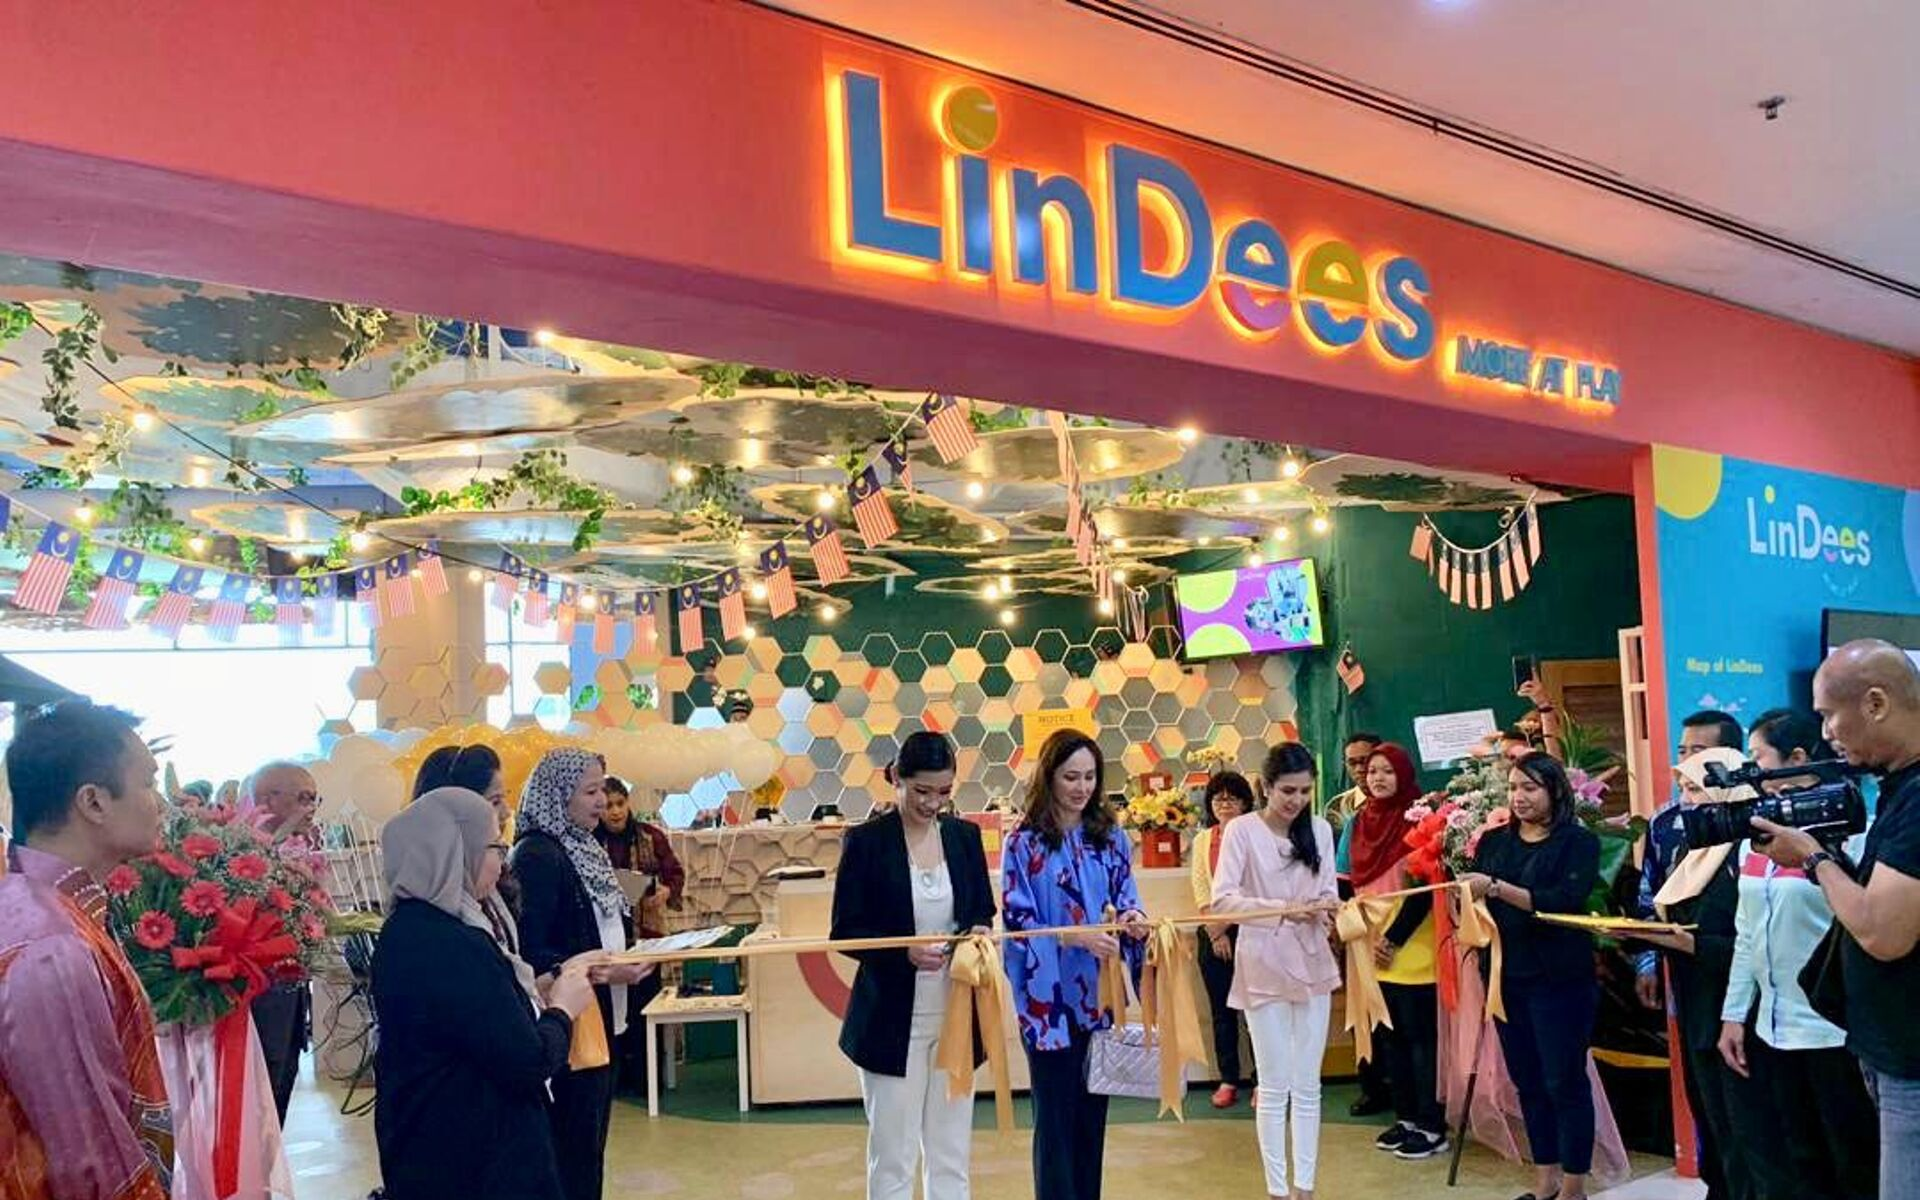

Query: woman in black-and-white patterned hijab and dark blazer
[513,747,653,1200]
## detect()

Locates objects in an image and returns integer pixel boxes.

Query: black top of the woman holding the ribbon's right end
[1473,822,1599,983]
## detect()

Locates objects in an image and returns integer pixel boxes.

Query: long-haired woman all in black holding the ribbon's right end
[1463,751,1599,1200]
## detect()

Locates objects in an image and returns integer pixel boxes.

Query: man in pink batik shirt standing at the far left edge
[0,701,173,1200]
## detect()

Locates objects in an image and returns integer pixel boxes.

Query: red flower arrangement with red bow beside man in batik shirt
[106,804,332,1025]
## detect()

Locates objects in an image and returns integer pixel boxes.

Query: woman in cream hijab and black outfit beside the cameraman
[1647,747,1793,1200]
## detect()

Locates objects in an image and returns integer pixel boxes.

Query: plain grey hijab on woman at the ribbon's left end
[380,787,540,1006]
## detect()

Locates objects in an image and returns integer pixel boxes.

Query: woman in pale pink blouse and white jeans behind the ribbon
[1210,741,1340,1200]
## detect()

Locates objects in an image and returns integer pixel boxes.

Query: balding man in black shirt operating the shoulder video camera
[1753,639,1920,1200]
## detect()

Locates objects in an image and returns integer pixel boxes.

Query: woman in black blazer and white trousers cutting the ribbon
[833,732,995,1200]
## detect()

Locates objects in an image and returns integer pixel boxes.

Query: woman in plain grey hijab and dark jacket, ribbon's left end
[372,787,593,1200]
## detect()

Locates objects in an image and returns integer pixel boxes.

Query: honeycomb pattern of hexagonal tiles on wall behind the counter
[614,628,1296,828]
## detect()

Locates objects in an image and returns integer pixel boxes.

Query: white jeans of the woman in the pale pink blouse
[1246,995,1332,1196]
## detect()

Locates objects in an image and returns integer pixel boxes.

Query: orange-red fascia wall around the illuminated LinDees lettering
[0,0,1920,490]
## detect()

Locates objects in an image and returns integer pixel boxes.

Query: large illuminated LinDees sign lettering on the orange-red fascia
[828,69,1620,411]
